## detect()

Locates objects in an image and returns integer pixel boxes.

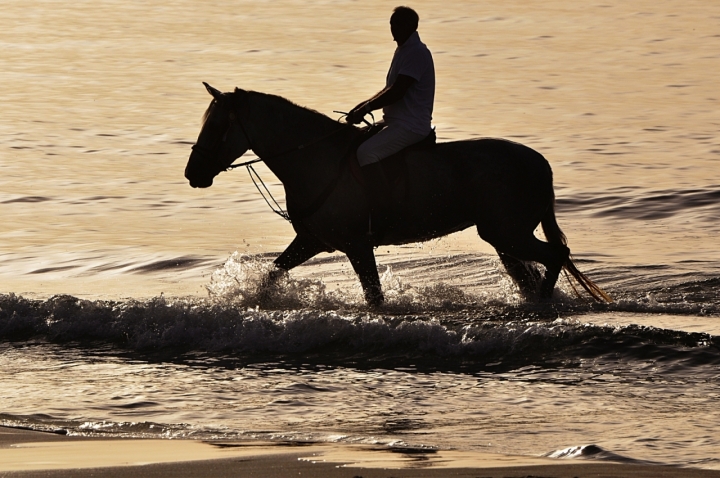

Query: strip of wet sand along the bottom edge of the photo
[0,427,720,478]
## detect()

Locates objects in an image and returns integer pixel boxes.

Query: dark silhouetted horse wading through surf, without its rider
[185,83,611,306]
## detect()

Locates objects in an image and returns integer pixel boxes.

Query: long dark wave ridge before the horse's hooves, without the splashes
[0,296,720,368]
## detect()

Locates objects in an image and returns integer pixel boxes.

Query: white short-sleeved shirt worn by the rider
[383,32,435,134]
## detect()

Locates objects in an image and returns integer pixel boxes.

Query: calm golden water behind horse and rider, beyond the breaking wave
[0,0,720,296]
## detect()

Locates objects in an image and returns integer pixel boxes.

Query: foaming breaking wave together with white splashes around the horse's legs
[0,254,720,367]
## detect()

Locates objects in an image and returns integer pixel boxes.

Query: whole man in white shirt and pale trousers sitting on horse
[347,7,435,238]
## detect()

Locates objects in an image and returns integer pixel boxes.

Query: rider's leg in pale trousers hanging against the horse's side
[357,124,425,235]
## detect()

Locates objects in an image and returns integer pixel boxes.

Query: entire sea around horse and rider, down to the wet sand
[0,0,720,469]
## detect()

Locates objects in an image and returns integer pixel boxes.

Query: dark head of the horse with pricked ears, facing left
[185,83,250,188]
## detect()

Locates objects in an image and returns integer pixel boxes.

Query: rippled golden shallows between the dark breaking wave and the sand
[0,338,720,467]
